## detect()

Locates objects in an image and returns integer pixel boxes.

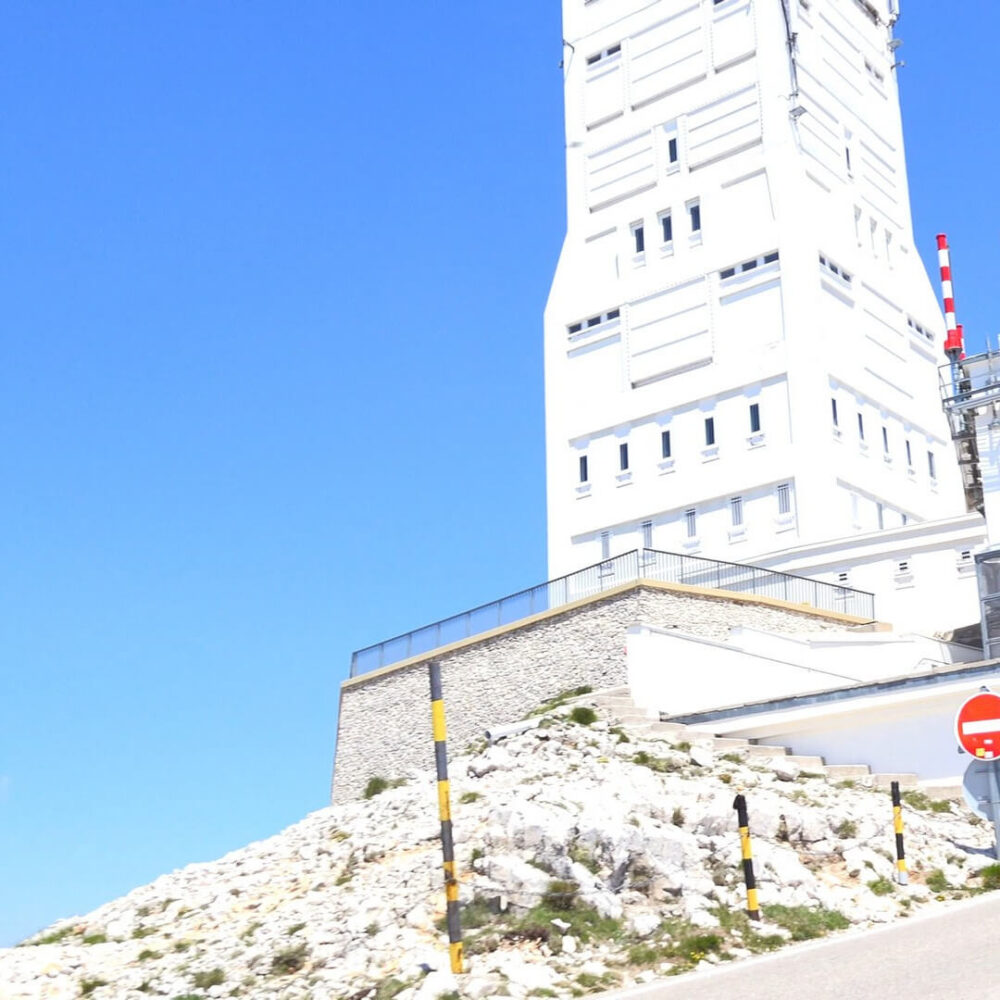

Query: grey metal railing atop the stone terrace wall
[351,549,875,677]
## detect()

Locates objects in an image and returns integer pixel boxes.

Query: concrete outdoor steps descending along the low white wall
[571,687,918,790]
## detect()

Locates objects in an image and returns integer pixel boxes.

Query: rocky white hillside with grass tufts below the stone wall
[0,707,998,1000]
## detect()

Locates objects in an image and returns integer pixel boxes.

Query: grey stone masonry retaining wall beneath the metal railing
[333,586,851,802]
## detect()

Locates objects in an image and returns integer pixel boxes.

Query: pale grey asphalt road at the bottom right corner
[604,893,1000,1000]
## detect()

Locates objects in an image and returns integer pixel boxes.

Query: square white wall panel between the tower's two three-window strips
[629,278,712,383]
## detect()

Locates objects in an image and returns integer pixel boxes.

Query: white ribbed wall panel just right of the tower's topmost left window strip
[629,4,705,107]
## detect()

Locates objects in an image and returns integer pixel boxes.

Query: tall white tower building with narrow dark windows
[545,0,966,576]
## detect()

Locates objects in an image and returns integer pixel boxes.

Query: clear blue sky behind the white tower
[0,0,1000,944]
